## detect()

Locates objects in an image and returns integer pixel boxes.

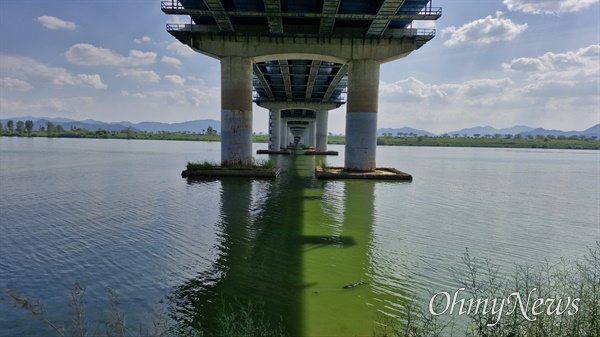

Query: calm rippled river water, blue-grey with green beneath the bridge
[0,137,600,336]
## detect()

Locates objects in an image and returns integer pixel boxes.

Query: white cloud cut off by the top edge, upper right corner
[503,0,599,14]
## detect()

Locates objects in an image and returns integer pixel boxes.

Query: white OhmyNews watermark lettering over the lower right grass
[429,288,580,326]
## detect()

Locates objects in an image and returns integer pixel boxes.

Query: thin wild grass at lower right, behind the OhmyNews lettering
[373,242,600,337]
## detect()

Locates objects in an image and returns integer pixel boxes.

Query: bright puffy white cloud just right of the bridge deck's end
[442,12,527,46]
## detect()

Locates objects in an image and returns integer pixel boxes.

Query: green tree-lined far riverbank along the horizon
[0,129,600,150]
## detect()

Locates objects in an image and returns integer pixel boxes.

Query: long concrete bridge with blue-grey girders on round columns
[161,0,442,171]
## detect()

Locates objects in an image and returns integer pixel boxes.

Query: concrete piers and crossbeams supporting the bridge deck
[171,25,420,168]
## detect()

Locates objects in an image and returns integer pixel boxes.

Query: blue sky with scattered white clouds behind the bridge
[0,0,600,134]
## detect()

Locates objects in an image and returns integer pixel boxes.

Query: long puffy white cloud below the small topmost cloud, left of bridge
[65,43,156,67]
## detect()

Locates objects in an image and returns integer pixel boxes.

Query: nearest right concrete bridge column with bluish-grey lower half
[344,60,379,171]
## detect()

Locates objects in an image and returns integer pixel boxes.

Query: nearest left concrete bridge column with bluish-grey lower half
[221,56,252,166]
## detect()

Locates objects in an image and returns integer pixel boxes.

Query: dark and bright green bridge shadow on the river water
[169,154,412,336]
